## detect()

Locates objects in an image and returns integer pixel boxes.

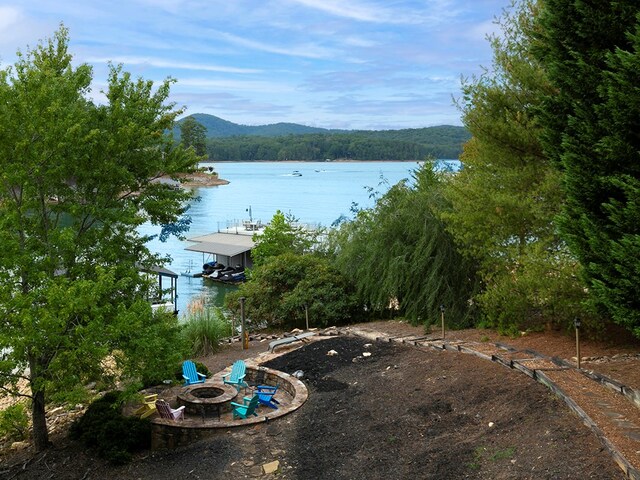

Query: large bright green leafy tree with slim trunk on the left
[0,27,197,449]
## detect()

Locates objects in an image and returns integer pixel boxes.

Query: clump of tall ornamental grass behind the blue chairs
[182,306,232,356]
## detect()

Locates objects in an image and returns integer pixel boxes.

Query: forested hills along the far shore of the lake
[174,113,471,161]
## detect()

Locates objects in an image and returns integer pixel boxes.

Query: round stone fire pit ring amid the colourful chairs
[177,383,238,419]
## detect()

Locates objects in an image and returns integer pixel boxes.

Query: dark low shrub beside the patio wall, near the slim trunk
[69,392,151,465]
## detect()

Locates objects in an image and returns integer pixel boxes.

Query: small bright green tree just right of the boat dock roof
[251,210,322,265]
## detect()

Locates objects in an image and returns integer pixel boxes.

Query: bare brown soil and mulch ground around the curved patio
[0,322,640,480]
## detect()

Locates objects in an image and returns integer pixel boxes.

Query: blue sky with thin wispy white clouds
[0,0,510,130]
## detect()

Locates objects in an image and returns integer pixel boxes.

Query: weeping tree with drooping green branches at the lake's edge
[330,162,476,328]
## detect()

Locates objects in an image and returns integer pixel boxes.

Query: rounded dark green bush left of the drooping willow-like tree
[225,253,356,329]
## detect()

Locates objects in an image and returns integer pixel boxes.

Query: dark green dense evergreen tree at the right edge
[535,0,640,336]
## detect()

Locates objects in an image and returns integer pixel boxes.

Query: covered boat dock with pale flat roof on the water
[185,233,255,268]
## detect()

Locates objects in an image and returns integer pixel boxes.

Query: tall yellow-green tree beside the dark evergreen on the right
[443,0,582,330]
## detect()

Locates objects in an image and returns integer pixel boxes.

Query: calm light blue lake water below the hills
[141,160,457,313]
